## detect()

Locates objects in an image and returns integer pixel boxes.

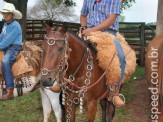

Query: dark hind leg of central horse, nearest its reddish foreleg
[100,99,107,122]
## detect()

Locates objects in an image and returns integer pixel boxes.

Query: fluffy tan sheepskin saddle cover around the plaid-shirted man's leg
[87,31,136,84]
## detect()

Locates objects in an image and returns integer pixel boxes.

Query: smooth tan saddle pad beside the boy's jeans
[0,51,33,79]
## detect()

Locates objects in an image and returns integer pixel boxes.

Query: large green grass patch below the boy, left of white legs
[0,91,43,122]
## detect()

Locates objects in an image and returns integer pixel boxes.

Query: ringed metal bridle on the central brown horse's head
[40,31,69,111]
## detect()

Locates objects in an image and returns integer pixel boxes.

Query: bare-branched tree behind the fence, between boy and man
[27,0,76,21]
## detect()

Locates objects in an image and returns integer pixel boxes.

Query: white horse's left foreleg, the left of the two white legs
[39,88,51,122]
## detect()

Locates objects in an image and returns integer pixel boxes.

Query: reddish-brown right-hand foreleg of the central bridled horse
[86,100,97,122]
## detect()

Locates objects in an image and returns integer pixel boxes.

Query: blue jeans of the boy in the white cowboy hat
[1,44,22,89]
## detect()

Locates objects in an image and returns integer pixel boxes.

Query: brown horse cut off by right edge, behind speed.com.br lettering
[145,34,163,122]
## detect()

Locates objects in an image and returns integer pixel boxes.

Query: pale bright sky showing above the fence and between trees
[0,0,158,23]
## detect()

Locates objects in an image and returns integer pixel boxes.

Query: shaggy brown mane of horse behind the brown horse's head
[23,41,42,68]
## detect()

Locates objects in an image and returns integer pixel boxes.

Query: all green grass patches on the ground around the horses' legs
[0,67,144,122]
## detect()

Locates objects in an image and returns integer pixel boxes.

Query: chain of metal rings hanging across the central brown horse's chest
[62,48,93,122]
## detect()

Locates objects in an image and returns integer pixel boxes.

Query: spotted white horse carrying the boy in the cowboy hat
[0,42,62,122]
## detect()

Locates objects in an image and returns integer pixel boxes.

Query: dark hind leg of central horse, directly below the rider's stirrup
[107,102,115,122]
